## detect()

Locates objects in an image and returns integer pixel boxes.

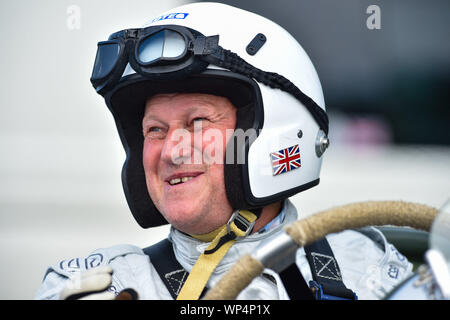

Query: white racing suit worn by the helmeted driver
[35,200,412,300]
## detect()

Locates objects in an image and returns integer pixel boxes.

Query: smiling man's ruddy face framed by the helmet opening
[142,93,236,234]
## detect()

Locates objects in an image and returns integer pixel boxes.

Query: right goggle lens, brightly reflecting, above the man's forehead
[137,30,186,64]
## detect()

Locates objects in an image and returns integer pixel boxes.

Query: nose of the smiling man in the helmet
[161,127,193,165]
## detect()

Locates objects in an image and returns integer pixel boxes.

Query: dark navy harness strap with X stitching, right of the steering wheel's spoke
[304,238,357,300]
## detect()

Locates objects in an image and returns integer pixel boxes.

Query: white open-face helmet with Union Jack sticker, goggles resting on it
[91,3,328,228]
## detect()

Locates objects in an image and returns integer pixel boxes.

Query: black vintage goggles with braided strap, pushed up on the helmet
[91,25,328,134]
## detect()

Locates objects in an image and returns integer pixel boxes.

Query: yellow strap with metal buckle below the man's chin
[177,210,258,300]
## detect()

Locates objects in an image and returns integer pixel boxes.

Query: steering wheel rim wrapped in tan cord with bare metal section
[204,201,439,300]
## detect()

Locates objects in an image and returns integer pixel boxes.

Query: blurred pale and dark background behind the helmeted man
[0,0,450,299]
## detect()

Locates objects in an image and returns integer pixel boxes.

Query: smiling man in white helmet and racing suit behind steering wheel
[37,3,412,299]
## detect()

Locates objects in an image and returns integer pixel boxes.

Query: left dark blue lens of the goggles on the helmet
[92,42,120,80]
